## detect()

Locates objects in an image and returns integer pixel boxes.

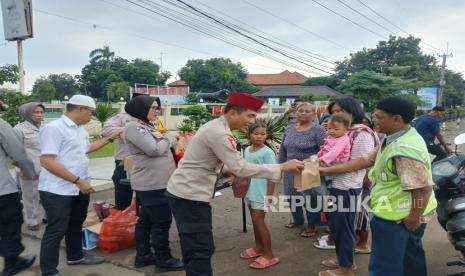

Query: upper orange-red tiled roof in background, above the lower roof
[247,70,308,86]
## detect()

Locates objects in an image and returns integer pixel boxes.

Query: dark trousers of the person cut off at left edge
[0,192,24,258]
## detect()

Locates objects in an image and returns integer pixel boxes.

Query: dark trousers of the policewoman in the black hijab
[136,189,176,262]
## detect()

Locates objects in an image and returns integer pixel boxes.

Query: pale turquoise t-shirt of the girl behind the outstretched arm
[244,146,276,203]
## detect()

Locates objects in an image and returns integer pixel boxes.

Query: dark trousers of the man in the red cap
[168,196,215,276]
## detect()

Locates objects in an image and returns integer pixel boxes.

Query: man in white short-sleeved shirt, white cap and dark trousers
[39,95,121,276]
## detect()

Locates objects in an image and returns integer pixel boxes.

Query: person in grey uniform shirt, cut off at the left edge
[0,97,37,276]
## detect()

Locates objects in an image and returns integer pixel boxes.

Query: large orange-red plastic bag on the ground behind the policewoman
[98,200,138,253]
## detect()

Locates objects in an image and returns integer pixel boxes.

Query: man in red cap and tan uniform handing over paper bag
[167,92,303,276]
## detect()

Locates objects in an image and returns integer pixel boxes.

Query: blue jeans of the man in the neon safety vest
[368,217,427,276]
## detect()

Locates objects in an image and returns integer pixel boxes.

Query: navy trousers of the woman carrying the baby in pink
[329,188,362,267]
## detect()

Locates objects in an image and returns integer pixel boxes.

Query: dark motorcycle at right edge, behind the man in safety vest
[432,133,465,276]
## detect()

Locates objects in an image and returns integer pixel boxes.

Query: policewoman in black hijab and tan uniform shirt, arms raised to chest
[124,95,184,272]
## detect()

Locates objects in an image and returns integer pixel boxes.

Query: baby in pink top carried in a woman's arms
[318,113,351,166]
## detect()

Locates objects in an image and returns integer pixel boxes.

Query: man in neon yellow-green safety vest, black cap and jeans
[369,97,437,276]
